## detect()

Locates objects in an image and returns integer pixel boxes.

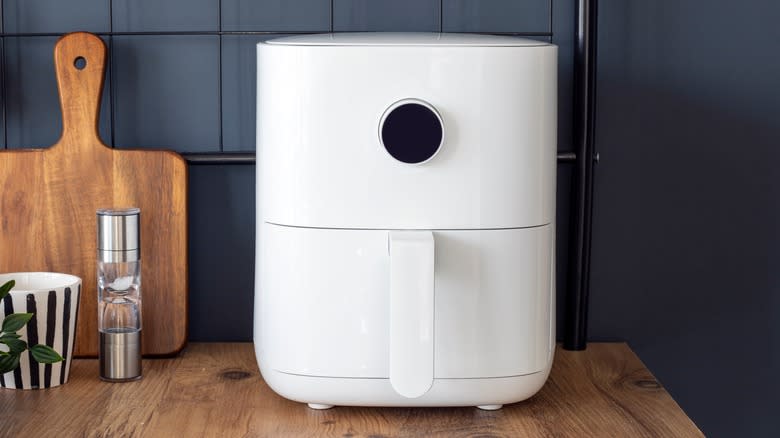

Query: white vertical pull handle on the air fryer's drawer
[388,231,434,398]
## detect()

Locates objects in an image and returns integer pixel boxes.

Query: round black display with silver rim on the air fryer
[379,102,443,164]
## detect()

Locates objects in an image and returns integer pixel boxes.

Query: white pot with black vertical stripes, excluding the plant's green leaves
[0,272,81,389]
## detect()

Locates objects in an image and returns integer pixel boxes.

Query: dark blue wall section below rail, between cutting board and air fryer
[189,165,255,340]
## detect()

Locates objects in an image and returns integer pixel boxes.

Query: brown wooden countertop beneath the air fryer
[0,343,703,437]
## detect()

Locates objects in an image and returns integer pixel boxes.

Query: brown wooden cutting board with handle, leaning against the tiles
[0,32,188,357]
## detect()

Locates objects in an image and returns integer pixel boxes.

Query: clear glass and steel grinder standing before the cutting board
[97,208,141,382]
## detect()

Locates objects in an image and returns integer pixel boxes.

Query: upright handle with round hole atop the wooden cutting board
[53,32,106,153]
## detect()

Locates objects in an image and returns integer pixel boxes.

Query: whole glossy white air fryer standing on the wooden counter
[254,33,557,409]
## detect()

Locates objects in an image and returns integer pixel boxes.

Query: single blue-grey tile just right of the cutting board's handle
[113,35,221,152]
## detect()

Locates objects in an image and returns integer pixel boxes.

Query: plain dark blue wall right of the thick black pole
[590,0,780,437]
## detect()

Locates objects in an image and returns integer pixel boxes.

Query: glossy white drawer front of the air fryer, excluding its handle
[255,224,555,378]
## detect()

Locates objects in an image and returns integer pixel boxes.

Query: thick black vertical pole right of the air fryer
[563,0,597,350]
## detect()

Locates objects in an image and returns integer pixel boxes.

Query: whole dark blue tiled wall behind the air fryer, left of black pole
[0,0,574,341]
